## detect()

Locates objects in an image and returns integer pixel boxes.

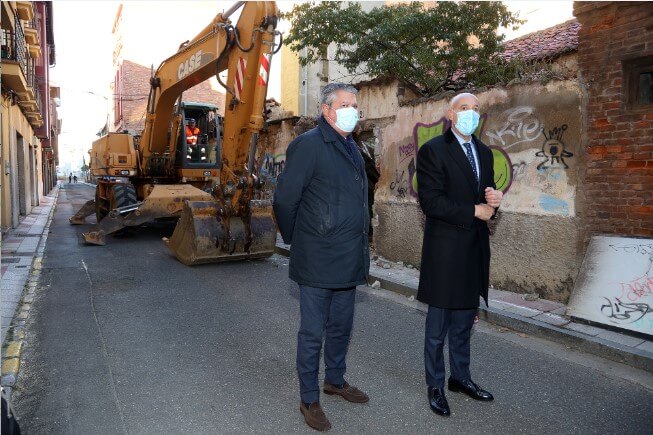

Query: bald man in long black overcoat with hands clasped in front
[417,93,503,416]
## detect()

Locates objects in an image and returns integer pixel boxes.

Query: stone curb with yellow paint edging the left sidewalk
[1,184,61,398]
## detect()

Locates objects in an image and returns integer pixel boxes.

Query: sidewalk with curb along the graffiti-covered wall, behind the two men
[276,237,653,372]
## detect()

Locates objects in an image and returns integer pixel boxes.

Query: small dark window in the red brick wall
[623,56,653,111]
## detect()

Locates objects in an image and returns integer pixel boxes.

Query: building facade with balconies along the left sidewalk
[0,1,61,229]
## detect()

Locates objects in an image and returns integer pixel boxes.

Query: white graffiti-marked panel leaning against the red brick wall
[569,236,653,334]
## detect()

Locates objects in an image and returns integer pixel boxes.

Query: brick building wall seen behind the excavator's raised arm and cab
[114,60,225,133]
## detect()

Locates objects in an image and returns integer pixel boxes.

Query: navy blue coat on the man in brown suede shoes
[273,118,370,289]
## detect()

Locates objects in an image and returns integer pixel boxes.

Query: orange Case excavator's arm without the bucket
[139,2,279,184]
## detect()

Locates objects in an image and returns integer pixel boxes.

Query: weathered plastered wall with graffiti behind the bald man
[359,81,581,301]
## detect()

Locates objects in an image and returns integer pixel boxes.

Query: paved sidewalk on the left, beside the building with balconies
[0,184,61,346]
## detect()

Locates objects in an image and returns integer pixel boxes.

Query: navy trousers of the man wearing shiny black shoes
[424,306,477,388]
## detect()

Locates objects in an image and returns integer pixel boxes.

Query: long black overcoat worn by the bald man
[417,129,495,309]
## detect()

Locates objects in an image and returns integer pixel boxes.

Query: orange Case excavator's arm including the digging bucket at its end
[160,2,278,265]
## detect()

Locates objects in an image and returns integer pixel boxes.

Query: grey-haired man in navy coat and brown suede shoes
[274,83,370,430]
